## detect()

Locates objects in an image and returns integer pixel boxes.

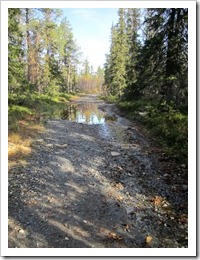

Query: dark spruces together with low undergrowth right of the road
[104,8,188,164]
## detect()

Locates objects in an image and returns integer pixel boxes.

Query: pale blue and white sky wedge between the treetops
[62,8,118,70]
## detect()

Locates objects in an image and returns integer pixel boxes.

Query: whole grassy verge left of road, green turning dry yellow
[8,93,73,165]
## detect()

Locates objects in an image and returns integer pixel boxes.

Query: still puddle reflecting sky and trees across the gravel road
[61,103,105,124]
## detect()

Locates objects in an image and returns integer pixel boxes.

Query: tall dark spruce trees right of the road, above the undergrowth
[104,8,188,106]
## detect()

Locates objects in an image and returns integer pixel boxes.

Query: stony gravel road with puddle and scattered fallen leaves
[9,95,187,248]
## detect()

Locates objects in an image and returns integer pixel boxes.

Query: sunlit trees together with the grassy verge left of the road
[8,8,103,167]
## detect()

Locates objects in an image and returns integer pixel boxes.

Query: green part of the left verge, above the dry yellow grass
[8,93,73,132]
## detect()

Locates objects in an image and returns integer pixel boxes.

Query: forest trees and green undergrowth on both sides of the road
[8,8,188,160]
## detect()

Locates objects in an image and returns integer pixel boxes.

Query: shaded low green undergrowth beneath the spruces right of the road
[117,100,188,164]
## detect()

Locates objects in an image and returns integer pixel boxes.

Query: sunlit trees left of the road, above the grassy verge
[8,8,103,95]
